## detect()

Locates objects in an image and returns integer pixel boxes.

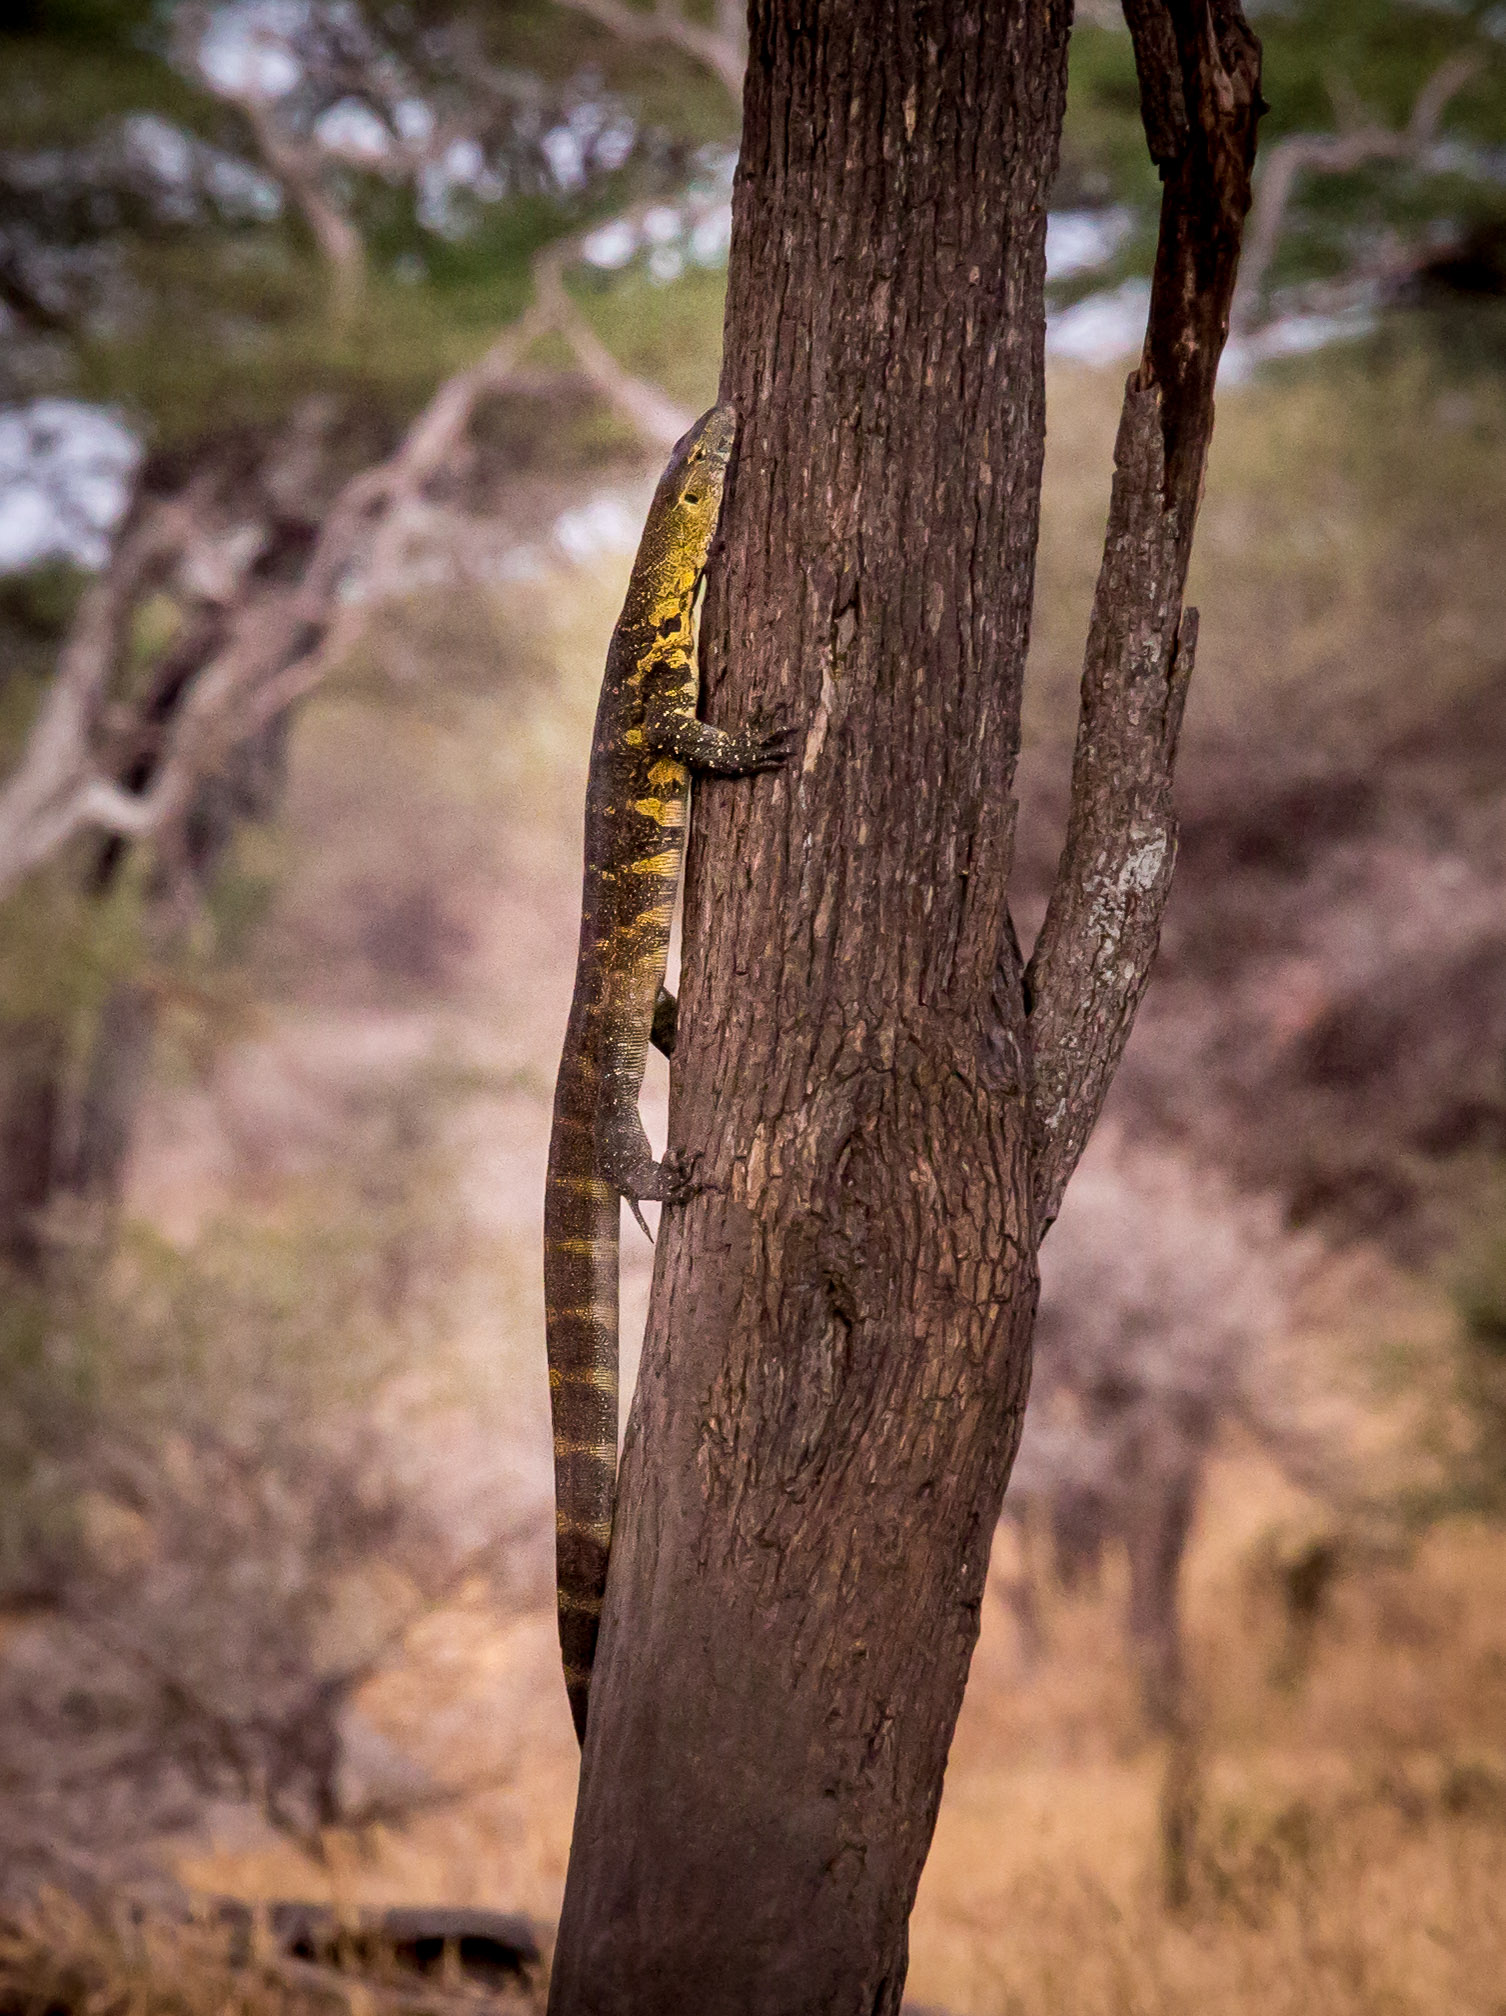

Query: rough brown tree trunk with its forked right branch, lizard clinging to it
[550,0,1260,2016]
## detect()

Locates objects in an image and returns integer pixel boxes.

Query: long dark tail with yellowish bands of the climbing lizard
[544,1079,619,1742]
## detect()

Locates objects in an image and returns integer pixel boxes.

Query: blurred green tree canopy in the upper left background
[0,0,736,444]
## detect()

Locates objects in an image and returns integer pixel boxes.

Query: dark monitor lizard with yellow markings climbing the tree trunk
[544,405,792,1742]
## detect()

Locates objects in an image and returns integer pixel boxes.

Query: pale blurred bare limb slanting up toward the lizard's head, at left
[0,222,692,897]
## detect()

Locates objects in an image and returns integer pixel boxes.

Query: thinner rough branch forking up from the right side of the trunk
[1026,0,1264,1230]
